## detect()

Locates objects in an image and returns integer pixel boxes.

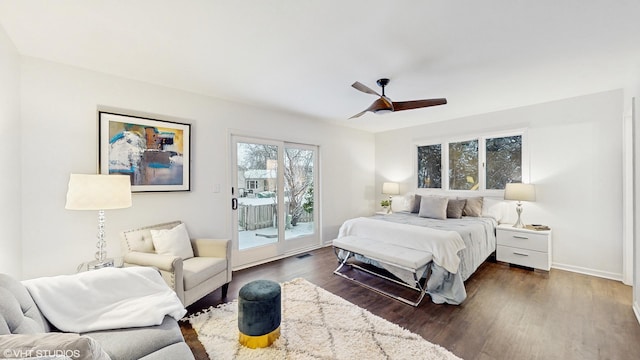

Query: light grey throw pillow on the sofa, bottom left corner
[0,333,109,360]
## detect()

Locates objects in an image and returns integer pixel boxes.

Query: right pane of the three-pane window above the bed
[486,135,522,190]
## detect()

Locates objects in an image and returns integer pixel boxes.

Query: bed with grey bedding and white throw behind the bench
[336,197,502,305]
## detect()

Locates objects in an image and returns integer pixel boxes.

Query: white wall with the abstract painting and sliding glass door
[21,58,374,278]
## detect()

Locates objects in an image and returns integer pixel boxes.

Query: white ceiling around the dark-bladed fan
[0,0,640,132]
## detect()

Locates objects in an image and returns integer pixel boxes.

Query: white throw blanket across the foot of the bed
[338,217,466,274]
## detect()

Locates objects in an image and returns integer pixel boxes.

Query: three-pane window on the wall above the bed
[417,133,524,190]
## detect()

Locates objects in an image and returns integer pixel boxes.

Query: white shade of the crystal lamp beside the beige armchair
[65,174,131,210]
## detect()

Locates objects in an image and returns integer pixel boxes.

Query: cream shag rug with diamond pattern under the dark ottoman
[186,279,461,360]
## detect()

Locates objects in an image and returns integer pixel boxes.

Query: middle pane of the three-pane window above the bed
[449,140,479,190]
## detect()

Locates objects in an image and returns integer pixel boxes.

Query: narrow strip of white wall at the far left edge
[0,27,22,278]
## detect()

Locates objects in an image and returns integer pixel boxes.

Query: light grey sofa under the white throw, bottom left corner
[0,274,194,360]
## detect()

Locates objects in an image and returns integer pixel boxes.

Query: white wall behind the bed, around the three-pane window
[376,90,624,280]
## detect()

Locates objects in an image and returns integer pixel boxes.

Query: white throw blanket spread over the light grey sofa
[23,267,187,333]
